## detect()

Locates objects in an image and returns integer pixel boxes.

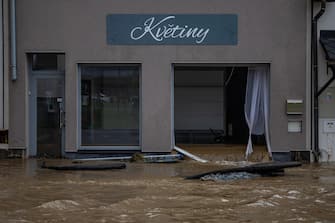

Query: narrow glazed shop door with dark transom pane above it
[28,54,65,158]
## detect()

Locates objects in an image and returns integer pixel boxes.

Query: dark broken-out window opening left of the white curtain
[174,65,266,160]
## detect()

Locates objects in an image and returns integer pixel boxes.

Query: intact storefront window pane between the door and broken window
[81,64,139,146]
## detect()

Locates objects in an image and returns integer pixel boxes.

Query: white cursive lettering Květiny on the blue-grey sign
[130,16,210,43]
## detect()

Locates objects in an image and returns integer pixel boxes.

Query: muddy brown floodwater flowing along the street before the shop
[0,159,335,223]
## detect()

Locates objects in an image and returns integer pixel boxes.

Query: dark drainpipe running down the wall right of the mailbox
[312,0,326,162]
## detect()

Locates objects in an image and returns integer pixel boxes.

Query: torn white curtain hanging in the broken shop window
[244,66,272,157]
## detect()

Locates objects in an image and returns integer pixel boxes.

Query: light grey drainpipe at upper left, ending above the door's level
[9,0,17,81]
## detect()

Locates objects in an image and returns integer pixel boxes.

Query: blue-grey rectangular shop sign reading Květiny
[107,14,237,45]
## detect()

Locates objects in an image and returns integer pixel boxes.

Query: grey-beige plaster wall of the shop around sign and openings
[9,0,306,152]
